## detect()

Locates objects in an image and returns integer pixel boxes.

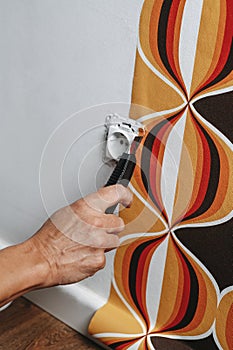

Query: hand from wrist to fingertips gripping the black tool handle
[27,185,132,287]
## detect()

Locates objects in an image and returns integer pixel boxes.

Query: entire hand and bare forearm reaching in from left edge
[0,185,132,306]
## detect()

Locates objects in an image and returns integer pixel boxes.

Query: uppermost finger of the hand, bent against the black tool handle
[85,184,133,212]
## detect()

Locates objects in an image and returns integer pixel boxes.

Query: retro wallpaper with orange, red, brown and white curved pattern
[89,0,233,350]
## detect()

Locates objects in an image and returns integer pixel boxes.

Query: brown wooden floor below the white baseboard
[0,298,102,350]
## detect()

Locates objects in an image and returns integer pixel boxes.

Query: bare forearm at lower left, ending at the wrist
[0,241,48,306]
